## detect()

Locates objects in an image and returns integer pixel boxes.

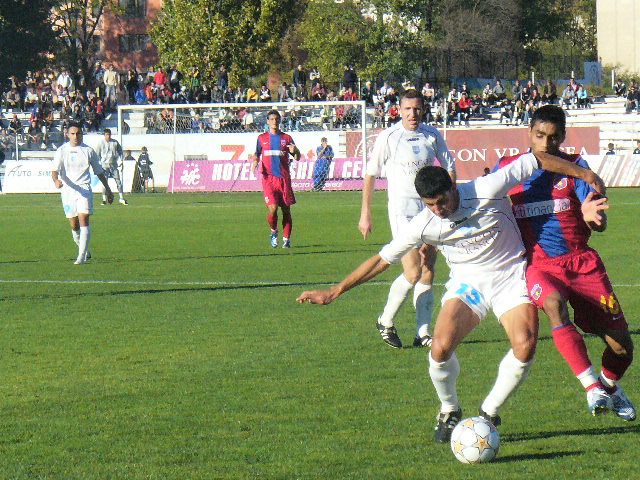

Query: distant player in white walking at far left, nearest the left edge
[51,125,113,265]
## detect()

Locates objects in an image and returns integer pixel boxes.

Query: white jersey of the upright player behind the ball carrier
[366,122,456,214]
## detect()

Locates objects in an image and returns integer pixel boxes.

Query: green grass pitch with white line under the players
[0,189,640,480]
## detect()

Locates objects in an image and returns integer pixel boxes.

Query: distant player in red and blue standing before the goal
[250,110,300,248]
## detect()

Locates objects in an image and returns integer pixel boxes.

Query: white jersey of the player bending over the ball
[380,154,538,276]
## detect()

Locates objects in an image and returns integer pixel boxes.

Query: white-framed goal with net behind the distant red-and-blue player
[118,101,374,192]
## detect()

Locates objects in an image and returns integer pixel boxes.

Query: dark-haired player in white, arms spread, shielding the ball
[297,153,604,443]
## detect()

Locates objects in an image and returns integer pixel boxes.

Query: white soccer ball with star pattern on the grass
[451,417,500,463]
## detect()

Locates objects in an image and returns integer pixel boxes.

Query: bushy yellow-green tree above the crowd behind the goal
[151,0,306,82]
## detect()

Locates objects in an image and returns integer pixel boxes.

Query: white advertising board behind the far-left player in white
[2,160,136,193]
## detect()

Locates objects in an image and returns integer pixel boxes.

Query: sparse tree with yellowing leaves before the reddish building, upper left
[51,0,120,87]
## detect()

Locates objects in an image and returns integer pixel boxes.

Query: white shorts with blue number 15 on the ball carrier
[442,259,531,320]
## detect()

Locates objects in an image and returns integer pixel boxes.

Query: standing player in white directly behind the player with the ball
[358,90,456,348]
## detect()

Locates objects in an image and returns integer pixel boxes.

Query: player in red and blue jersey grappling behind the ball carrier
[497,105,636,421]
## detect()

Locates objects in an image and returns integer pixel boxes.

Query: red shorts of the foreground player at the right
[527,249,629,334]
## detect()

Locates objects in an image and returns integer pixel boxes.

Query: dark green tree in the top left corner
[0,0,54,82]
